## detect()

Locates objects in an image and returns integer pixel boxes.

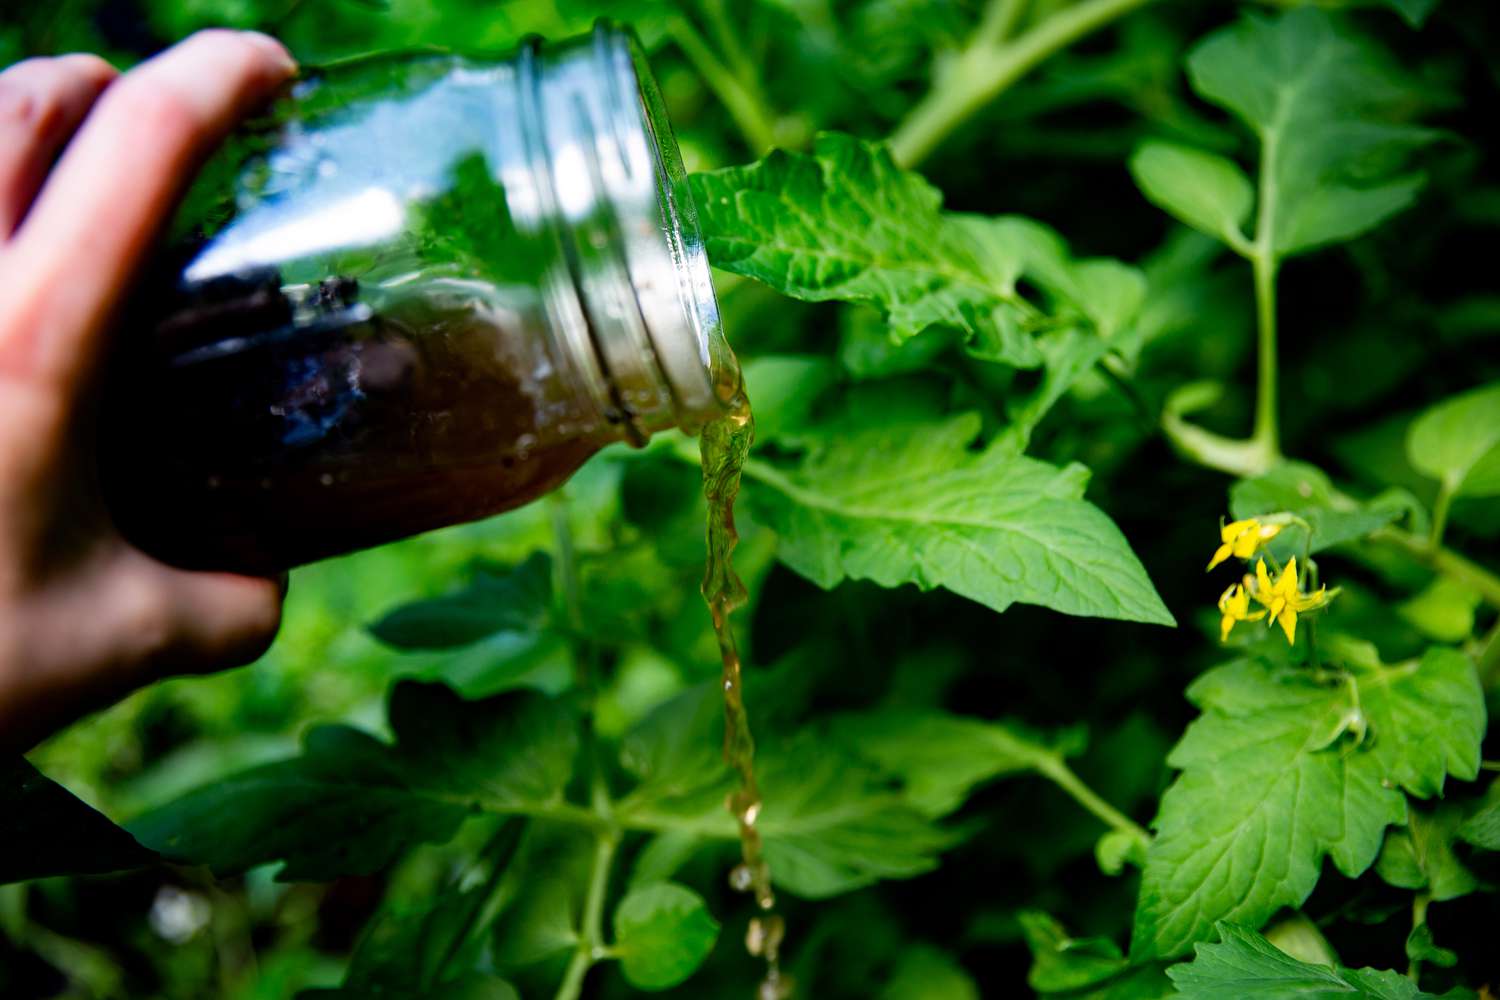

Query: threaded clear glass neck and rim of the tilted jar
[512,22,740,444]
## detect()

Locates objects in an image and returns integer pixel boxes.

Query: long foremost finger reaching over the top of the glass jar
[0,30,294,388]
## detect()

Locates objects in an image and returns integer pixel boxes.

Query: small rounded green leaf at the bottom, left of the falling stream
[615,882,719,990]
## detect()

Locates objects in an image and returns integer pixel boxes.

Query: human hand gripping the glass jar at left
[0,31,294,750]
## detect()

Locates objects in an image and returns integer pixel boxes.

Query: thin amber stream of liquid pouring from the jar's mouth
[699,387,791,1000]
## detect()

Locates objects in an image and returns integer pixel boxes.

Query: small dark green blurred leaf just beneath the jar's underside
[371,552,552,649]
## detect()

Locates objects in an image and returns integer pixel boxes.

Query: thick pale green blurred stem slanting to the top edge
[891,0,1154,166]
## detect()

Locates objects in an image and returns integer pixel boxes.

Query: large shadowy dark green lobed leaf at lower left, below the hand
[129,681,579,882]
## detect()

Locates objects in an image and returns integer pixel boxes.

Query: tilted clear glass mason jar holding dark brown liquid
[99,22,740,573]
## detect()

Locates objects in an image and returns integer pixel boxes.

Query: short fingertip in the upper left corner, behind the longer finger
[0,55,117,241]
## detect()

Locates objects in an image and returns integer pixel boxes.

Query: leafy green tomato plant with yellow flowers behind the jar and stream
[0,0,1500,1000]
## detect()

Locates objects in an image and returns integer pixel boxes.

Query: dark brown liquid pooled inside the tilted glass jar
[101,276,620,573]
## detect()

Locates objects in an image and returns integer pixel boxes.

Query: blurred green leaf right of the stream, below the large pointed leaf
[833,709,1082,817]
